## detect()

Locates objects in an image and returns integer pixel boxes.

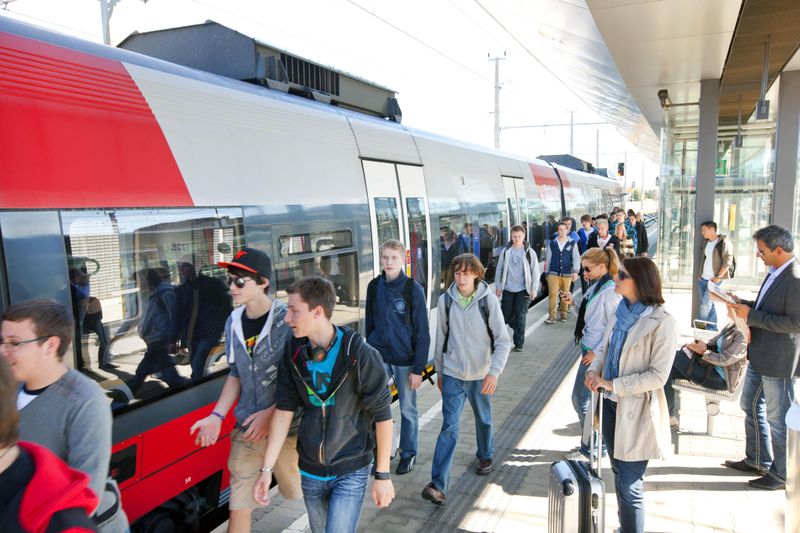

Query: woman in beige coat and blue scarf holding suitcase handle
[584,257,678,533]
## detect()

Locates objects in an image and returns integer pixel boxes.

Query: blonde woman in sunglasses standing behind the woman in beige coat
[568,247,621,459]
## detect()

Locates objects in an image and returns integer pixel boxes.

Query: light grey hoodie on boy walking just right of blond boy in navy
[433,281,511,381]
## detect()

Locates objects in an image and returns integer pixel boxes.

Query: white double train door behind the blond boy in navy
[363,161,431,307]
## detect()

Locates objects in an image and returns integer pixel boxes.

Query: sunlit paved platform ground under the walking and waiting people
[216,293,785,533]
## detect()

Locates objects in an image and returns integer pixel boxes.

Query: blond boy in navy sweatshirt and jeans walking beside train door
[366,239,430,475]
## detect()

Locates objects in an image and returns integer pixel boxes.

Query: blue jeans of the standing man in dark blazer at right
[739,367,794,482]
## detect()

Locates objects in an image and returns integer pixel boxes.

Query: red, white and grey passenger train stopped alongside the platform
[0,17,621,531]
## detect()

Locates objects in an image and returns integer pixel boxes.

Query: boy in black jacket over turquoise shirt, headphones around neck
[254,276,394,533]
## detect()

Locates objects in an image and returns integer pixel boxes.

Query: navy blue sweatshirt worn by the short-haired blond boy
[364,272,431,376]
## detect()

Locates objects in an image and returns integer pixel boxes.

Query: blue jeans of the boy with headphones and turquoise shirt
[301,466,371,533]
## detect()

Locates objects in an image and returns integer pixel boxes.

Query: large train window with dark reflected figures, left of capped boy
[61,208,244,408]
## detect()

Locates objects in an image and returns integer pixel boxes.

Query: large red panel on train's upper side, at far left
[0,34,193,208]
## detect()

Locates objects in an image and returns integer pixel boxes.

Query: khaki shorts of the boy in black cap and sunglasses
[228,429,303,510]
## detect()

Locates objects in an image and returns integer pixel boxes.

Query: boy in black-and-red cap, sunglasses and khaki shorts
[190,248,302,532]
